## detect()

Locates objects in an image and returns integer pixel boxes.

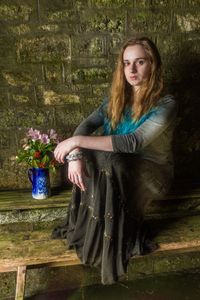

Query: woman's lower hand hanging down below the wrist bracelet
[68,160,89,191]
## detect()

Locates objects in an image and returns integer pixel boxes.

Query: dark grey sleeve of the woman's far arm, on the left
[73,100,106,136]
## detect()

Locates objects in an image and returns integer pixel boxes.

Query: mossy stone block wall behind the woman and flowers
[0,0,200,189]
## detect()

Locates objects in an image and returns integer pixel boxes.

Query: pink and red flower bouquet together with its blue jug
[16,128,59,199]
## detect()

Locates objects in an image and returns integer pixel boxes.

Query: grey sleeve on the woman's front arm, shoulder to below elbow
[111,95,177,153]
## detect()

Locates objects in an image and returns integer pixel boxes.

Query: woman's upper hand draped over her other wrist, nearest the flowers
[54,136,78,163]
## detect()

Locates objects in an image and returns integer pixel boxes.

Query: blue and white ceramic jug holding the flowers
[28,168,51,199]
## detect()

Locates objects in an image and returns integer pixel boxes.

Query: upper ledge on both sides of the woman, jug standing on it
[0,187,200,225]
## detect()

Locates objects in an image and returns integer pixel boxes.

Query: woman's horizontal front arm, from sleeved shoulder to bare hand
[54,95,176,162]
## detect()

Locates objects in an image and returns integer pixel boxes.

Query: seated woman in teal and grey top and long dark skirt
[53,38,176,284]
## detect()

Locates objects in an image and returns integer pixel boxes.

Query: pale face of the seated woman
[123,45,151,90]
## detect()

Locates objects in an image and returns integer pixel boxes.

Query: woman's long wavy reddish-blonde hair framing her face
[107,37,163,128]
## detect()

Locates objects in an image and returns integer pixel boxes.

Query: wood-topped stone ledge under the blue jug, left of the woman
[0,190,71,225]
